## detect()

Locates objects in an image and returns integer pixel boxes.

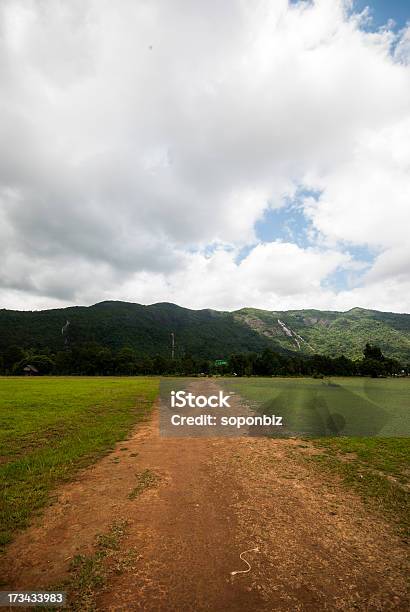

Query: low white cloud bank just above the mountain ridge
[3,241,351,309]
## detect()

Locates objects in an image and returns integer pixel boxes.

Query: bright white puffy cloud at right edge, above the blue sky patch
[306,116,410,248]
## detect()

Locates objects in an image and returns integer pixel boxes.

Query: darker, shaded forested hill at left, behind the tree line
[0,302,278,359]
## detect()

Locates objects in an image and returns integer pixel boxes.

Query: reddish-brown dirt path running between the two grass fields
[0,381,410,612]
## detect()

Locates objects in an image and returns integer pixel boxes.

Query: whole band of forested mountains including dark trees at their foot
[0,302,410,376]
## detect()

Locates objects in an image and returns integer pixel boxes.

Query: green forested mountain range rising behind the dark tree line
[0,301,410,361]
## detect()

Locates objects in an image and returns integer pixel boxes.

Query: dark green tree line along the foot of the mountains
[0,342,410,377]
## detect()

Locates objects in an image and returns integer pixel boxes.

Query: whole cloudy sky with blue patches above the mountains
[0,0,410,312]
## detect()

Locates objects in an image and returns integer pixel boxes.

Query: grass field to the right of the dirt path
[224,378,410,531]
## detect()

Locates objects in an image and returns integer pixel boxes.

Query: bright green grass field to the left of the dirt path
[0,377,159,545]
